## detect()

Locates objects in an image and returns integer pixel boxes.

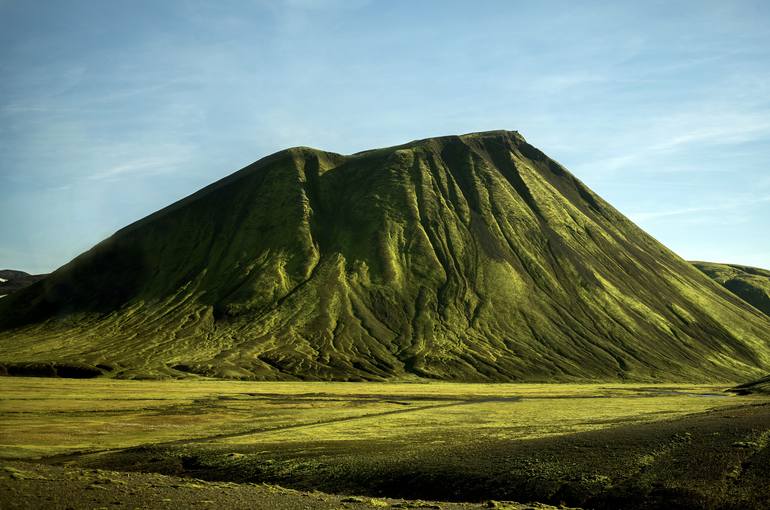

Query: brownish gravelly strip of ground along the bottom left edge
[0,462,564,510]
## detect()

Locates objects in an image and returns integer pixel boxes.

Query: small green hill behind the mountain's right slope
[693,261,770,316]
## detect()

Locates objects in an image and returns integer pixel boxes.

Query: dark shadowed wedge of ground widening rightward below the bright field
[63,400,770,509]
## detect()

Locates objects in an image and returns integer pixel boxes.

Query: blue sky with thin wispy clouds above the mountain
[0,0,770,272]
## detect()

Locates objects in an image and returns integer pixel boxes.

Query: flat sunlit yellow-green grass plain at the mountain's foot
[0,378,741,458]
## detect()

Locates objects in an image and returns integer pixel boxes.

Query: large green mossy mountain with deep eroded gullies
[0,131,770,381]
